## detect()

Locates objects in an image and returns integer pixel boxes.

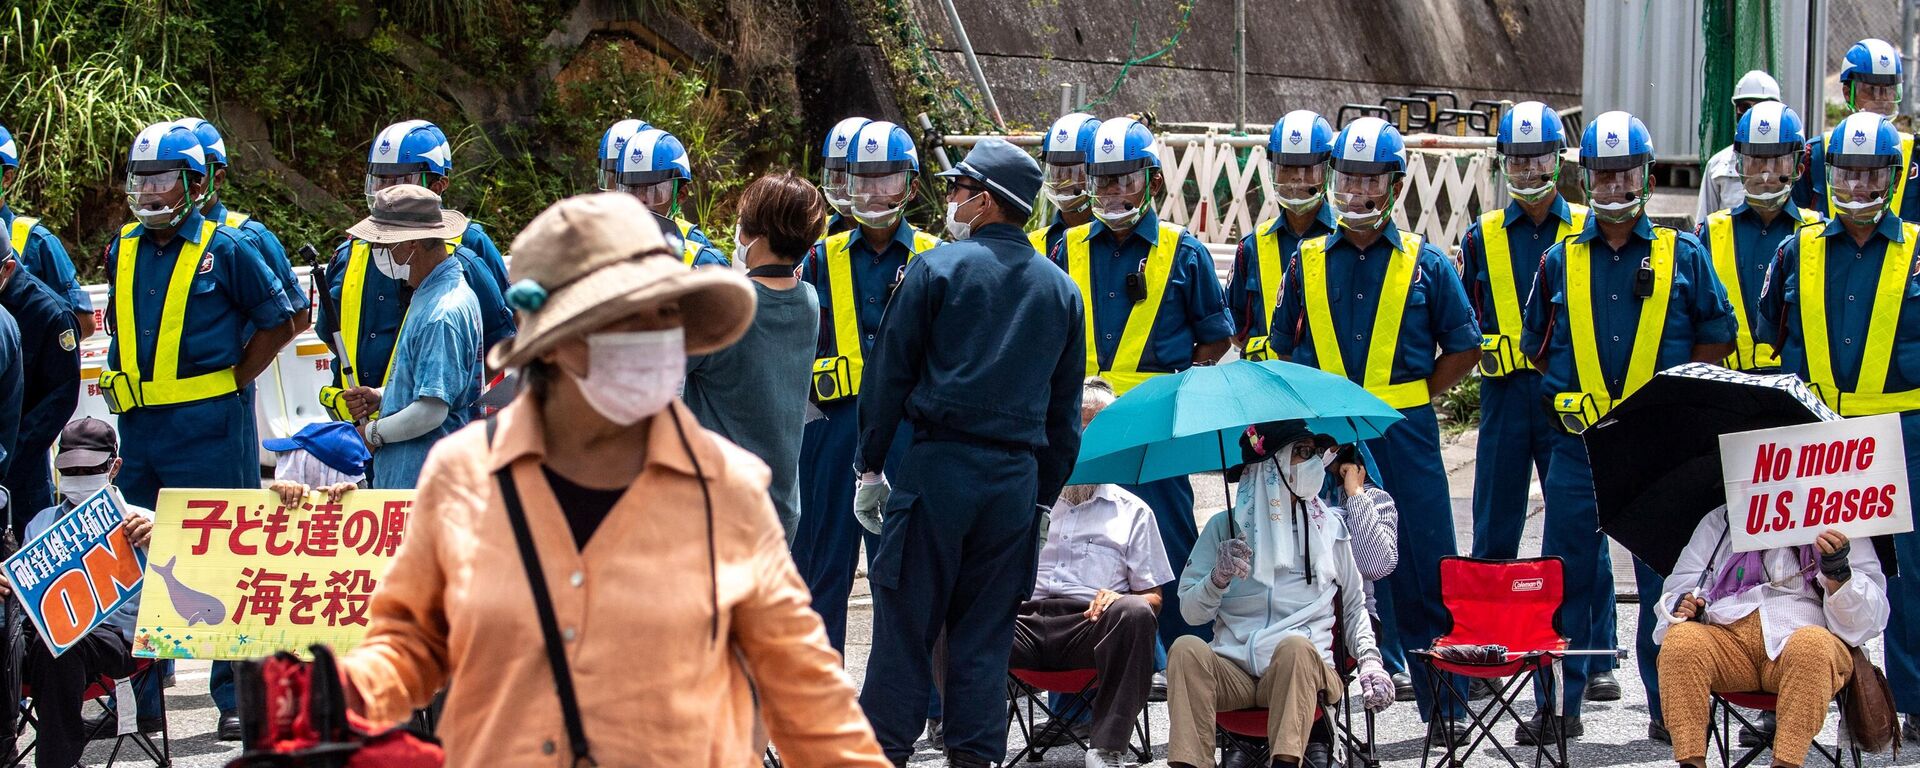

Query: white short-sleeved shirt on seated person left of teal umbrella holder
[1033,484,1173,601]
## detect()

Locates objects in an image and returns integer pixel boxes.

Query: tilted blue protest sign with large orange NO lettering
[6,488,146,657]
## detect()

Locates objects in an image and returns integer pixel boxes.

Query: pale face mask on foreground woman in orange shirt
[574,328,687,426]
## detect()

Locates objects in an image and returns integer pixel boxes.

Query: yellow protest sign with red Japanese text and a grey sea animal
[132,490,413,659]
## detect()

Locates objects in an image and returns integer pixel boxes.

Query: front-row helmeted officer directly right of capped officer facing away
[1052,117,1233,647]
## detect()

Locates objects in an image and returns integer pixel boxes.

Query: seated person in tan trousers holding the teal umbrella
[1167,420,1394,768]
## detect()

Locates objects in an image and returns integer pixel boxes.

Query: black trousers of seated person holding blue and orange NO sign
[21,624,132,768]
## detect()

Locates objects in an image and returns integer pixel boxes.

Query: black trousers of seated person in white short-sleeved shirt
[1010,595,1160,749]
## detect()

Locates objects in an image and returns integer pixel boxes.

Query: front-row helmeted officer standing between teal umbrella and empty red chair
[1267,117,1480,722]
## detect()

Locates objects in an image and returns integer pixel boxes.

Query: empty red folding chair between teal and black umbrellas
[1407,557,1567,768]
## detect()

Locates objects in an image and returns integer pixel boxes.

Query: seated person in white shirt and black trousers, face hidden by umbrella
[1008,378,1173,768]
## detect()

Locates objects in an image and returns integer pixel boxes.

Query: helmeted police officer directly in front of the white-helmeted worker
[1693,102,1822,372]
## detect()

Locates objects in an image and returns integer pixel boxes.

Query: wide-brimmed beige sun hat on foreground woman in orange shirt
[488,192,755,369]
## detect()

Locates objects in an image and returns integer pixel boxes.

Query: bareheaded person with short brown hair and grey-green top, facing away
[682,171,828,545]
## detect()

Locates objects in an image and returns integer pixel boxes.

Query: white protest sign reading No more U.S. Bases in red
[1720,415,1914,551]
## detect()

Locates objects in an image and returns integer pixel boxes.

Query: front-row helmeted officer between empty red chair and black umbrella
[1515,111,1734,745]
